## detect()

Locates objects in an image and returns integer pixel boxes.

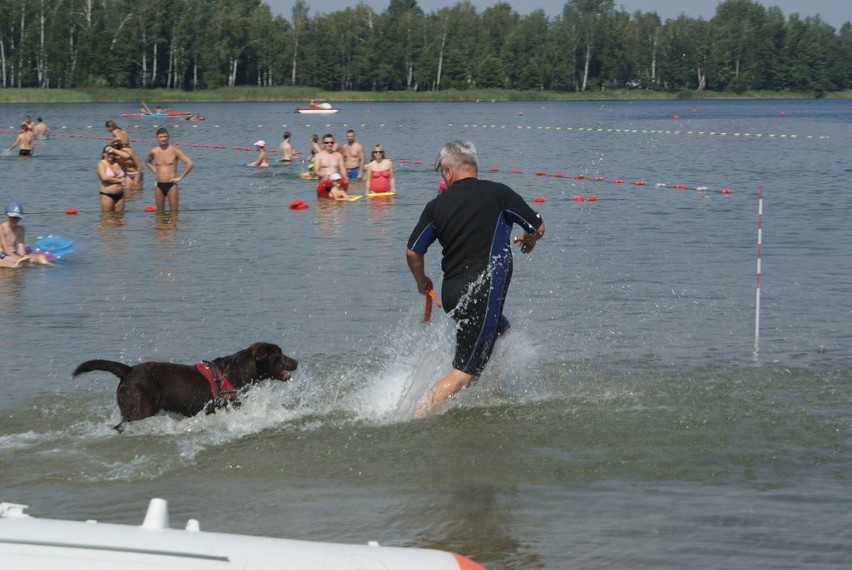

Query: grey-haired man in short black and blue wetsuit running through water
[406,141,544,417]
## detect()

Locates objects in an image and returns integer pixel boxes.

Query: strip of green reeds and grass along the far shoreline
[0,87,852,104]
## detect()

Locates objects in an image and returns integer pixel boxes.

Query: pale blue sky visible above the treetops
[266,0,852,28]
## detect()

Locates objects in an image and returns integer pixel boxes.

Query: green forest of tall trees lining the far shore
[0,0,852,96]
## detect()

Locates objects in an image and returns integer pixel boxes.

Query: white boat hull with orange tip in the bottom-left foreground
[0,499,485,570]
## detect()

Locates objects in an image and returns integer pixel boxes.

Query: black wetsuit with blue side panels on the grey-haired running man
[408,178,542,376]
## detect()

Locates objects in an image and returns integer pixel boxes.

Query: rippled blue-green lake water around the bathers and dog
[0,100,852,569]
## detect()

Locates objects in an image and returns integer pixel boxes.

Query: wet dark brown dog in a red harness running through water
[73,342,299,431]
